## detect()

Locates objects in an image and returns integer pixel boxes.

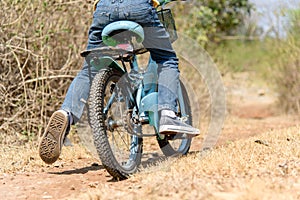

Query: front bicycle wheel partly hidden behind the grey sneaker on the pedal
[157,81,192,156]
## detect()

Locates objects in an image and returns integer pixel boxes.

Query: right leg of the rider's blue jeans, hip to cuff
[120,0,179,111]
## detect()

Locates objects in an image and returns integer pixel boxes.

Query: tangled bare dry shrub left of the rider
[0,0,92,142]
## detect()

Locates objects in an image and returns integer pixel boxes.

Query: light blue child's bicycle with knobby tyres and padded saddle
[81,2,196,180]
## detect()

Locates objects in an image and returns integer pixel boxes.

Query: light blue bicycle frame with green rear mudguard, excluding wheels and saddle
[83,47,186,139]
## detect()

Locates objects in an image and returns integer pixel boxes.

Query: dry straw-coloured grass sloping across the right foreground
[73,127,300,199]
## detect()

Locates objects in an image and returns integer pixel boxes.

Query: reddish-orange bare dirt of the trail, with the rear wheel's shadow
[0,116,297,200]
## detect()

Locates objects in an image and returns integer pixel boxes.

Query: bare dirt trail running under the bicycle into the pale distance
[0,72,299,200]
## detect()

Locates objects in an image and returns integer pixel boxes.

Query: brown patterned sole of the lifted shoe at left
[39,111,68,164]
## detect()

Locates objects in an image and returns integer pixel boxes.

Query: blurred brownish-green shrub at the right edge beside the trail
[275,38,300,114]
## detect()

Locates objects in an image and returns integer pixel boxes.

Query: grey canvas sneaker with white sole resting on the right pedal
[159,110,200,136]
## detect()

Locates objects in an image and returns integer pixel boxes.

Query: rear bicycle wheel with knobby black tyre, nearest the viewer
[89,69,142,180]
